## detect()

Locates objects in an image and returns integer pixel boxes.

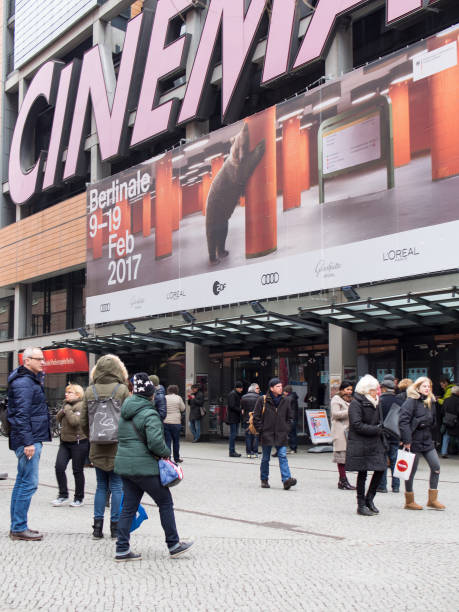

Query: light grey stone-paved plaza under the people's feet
[0,438,459,612]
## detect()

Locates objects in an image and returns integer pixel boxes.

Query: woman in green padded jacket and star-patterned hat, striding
[115,372,193,561]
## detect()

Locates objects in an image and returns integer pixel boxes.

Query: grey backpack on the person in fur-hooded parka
[88,384,122,444]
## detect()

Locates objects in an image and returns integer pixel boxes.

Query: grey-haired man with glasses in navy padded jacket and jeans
[8,347,51,541]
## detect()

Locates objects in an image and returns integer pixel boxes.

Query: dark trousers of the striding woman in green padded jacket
[116,476,179,553]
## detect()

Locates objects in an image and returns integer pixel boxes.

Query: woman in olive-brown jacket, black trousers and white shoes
[51,384,89,508]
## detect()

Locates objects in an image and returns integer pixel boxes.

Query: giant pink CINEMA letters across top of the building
[9,0,438,204]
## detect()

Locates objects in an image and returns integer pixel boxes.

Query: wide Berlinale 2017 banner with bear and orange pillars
[87,26,459,323]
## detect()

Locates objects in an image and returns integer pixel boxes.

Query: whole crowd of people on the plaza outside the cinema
[4,347,459,561]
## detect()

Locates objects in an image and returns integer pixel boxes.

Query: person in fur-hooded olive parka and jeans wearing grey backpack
[80,355,129,540]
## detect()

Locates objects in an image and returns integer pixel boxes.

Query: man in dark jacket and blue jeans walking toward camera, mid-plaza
[253,378,297,490]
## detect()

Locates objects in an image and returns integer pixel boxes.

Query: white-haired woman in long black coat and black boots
[346,374,387,516]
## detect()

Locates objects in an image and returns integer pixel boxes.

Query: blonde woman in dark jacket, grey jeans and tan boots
[399,376,445,510]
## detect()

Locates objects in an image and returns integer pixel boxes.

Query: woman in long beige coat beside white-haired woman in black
[330,380,355,491]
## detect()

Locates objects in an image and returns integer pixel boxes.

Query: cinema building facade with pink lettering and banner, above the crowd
[0,0,459,431]
